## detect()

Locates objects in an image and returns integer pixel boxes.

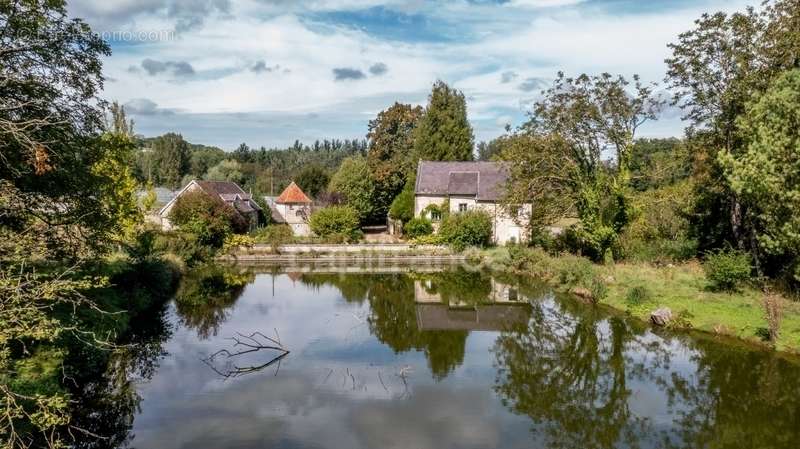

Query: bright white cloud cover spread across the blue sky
[89,0,756,147]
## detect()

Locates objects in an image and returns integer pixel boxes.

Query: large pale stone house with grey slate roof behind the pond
[414,161,532,244]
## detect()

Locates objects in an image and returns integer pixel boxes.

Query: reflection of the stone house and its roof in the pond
[414,279,531,331]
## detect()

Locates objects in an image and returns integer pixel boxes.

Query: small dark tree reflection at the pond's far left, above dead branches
[175,265,255,339]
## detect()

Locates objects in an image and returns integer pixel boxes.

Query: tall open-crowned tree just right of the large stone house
[508,73,662,260]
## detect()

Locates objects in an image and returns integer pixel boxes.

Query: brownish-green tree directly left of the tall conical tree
[367,103,422,220]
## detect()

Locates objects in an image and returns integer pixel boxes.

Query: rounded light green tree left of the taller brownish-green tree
[328,157,381,224]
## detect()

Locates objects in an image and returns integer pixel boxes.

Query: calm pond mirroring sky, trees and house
[81,267,800,449]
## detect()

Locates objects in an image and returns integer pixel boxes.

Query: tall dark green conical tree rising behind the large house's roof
[414,81,474,161]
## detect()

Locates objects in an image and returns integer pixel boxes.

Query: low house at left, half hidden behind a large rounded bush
[158,181,261,231]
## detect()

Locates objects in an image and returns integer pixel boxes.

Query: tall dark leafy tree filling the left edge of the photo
[0,0,142,440]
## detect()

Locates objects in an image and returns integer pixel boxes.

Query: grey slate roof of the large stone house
[414,161,508,201]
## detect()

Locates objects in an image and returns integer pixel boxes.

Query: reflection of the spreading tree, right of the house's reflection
[494,294,668,448]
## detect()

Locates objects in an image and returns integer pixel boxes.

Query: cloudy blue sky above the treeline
[68,0,756,150]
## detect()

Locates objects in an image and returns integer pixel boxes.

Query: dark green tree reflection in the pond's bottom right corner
[663,337,800,449]
